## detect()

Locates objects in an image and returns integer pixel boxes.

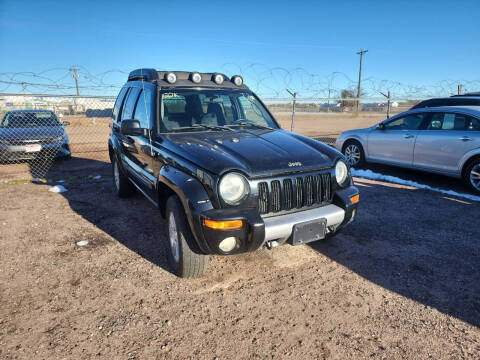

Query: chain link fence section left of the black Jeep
[0,94,115,181]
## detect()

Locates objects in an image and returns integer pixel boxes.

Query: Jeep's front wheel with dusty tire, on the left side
[166,195,209,278]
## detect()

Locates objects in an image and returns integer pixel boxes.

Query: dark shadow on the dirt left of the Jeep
[41,158,171,272]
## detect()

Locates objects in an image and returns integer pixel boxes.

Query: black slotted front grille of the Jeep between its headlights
[258,173,332,214]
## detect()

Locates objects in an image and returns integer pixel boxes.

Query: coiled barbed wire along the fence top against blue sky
[0,63,480,99]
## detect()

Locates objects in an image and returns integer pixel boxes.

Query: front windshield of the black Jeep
[160,89,278,132]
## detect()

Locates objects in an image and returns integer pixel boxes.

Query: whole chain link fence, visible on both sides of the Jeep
[0,94,418,182]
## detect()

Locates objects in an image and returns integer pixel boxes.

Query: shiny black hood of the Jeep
[162,129,341,177]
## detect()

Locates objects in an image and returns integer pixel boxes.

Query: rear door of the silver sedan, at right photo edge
[413,111,480,174]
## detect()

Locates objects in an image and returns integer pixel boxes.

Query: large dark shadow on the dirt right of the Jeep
[312,176,480,326]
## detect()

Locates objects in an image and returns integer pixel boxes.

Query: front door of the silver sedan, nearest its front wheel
[367,113,425,167]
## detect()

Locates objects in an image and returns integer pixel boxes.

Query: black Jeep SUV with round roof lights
[108,69,359,277]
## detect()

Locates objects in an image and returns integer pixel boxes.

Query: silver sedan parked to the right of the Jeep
[335,106,480,193]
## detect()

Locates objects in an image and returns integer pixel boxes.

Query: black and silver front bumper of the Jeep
[194,186,358,255]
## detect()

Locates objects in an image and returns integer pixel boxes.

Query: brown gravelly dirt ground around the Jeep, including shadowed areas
[0,159,480,359]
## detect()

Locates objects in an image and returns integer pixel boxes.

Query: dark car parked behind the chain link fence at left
[0,110,70,162]
